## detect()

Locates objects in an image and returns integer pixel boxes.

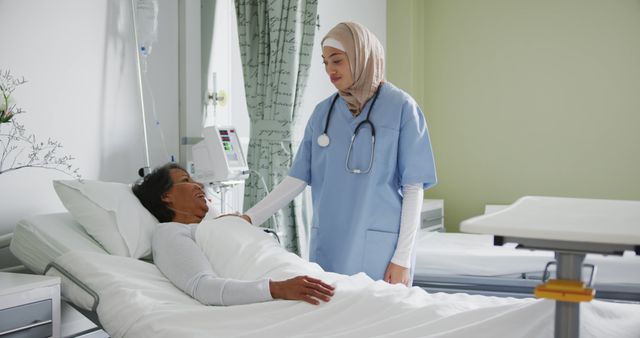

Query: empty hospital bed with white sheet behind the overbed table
[413,230,640,302]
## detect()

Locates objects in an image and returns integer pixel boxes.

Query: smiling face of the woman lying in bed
[162,169,209,224]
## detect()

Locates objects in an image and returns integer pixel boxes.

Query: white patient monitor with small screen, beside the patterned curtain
[192,126,249,184]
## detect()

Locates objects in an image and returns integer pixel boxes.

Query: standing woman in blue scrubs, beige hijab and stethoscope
[243,22,436,285]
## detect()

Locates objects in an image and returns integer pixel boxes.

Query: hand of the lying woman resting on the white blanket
[269,276,335,305]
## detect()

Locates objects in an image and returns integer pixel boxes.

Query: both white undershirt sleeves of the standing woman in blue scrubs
[245,176,423,268]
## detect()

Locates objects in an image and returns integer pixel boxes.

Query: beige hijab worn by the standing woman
[321,22,384,116]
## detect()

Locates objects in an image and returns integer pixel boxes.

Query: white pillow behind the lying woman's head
[53,180,158,258]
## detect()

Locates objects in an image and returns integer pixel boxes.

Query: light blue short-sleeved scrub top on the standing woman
[289,82,436,279]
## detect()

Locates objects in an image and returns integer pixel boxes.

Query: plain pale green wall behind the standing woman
[387,0,640,231]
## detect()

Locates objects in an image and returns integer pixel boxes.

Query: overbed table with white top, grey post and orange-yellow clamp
[460,196,640,338]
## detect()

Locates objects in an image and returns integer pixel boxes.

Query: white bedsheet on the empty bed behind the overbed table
[415,231,640,285]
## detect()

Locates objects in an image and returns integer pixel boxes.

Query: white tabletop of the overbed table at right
[460,196,640,245]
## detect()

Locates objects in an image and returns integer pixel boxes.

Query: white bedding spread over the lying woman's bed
[52,218,640,338]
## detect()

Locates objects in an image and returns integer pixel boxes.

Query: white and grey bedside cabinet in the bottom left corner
[0,272,60,338]
